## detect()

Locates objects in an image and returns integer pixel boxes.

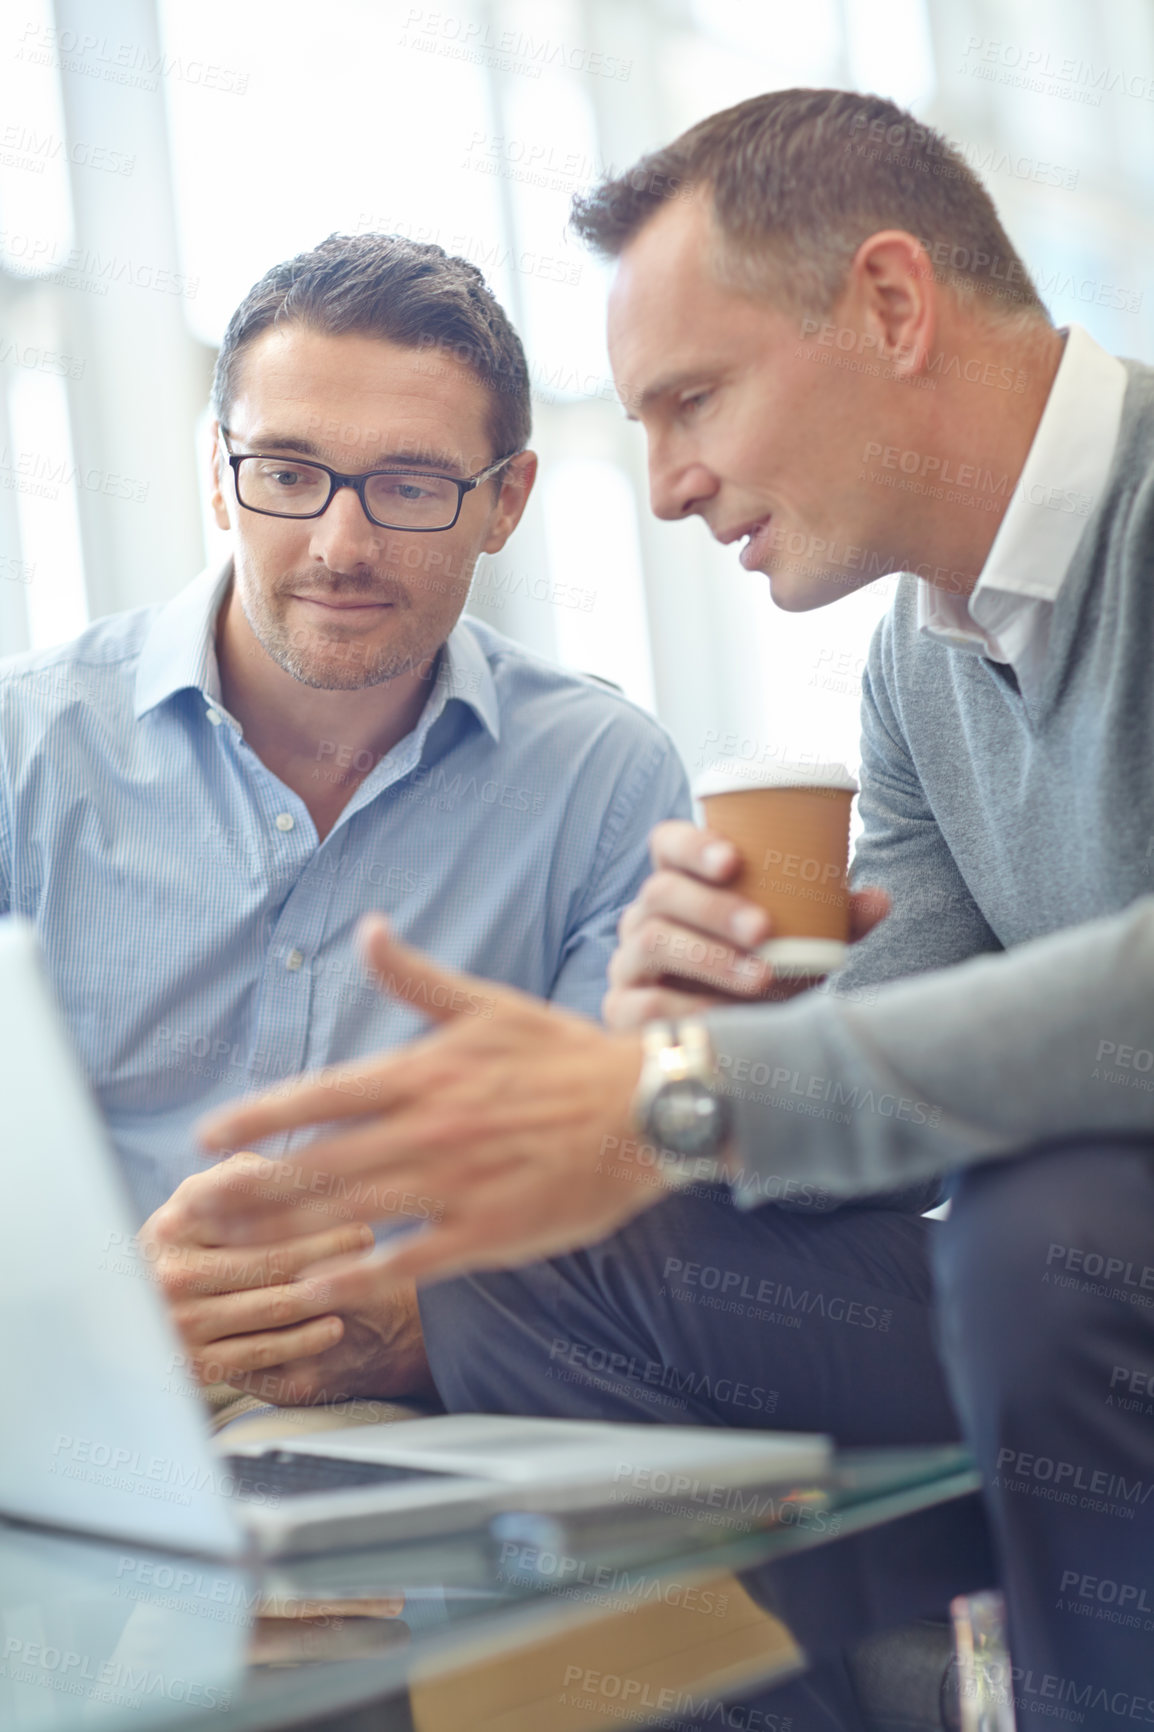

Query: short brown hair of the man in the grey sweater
[572,90,1048,322]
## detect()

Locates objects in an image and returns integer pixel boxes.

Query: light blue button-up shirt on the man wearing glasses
[0,568,690,1216]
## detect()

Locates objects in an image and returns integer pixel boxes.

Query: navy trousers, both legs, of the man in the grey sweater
[421,1141,1154,1732]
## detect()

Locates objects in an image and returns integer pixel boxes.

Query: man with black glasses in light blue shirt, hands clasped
[0,234,688,1403]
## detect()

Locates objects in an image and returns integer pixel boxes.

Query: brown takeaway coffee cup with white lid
[693,762,858,980]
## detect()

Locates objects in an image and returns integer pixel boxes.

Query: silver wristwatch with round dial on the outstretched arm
[632,1020,731,1185]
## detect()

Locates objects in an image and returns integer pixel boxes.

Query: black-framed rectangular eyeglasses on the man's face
[220,426,520,535]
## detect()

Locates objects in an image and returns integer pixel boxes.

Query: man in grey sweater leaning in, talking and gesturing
[193,92,1154,1727]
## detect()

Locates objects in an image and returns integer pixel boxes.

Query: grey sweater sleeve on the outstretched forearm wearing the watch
[707,895,1154,1207]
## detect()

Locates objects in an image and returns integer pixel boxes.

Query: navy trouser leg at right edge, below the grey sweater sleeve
[934,1140,1154,1732]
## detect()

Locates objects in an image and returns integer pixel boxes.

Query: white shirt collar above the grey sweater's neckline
[918,326,1126,662]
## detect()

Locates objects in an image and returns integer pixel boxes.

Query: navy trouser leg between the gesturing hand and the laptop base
[421,1190,960,1444]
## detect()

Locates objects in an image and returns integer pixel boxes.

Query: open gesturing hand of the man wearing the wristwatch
[196,916,665,1282]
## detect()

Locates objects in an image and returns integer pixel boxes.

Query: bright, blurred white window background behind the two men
[0,0,1154,786]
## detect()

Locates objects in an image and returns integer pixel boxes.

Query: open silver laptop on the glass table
[0,916,832,1559]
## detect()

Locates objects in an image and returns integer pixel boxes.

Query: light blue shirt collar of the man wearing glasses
[135,559,501,741]
